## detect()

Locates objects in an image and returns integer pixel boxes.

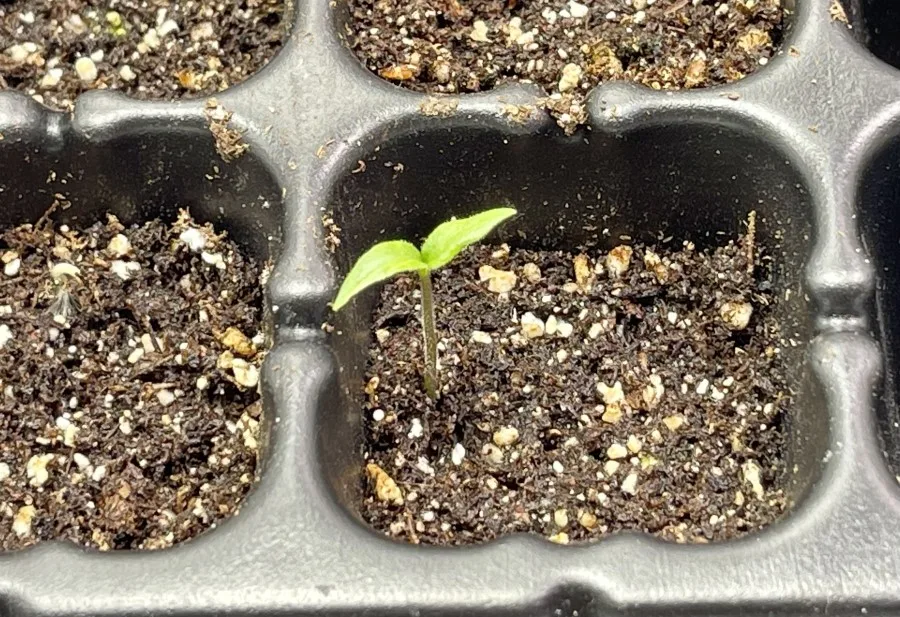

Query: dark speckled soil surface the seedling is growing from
[361,231,792,544]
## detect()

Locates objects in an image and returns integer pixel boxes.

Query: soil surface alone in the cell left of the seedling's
[0,214,265,550]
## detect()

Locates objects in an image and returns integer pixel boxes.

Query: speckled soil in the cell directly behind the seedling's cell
[348,0,784,132]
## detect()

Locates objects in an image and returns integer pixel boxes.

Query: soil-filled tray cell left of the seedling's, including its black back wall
[0,120,282,550]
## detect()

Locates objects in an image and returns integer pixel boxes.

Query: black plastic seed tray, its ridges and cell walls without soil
[0,0,900,616]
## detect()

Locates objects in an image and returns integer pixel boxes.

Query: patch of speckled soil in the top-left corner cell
[0,0,287,110]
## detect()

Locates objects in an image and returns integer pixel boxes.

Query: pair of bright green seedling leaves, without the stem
[331,208,516,311]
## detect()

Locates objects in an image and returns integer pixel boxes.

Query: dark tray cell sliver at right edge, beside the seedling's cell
[860,135,900,473]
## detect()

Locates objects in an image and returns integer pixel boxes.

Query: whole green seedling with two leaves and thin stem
[331,208,516,400]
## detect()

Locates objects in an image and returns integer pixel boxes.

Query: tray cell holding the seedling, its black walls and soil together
[320,122,827,544]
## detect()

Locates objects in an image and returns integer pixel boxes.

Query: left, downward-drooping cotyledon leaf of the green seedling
[331,240,428,311]
